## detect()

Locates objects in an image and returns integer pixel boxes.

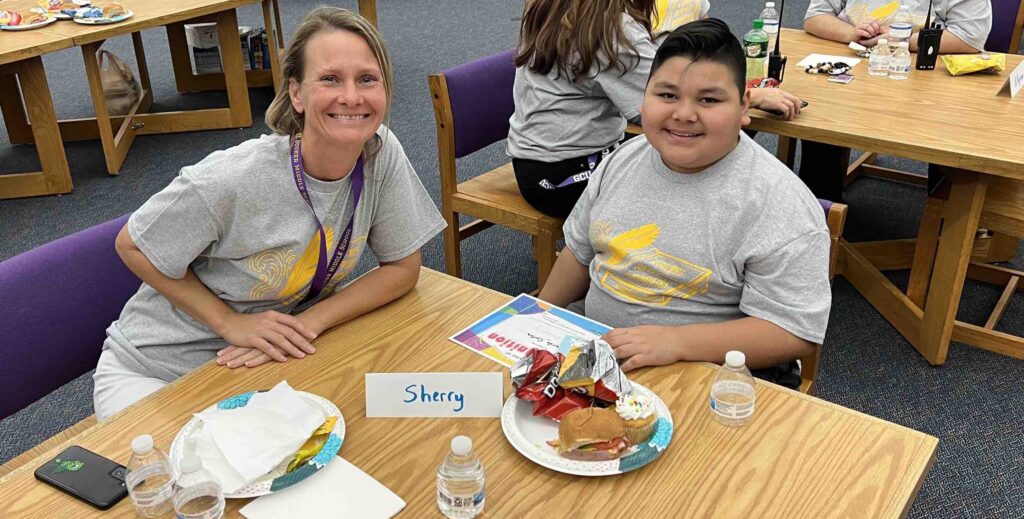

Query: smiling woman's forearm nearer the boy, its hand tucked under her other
[217,251,422,367]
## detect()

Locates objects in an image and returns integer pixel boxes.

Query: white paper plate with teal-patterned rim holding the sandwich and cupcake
[502,381,673,476]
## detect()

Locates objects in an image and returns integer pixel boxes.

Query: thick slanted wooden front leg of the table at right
[914,169,988,365]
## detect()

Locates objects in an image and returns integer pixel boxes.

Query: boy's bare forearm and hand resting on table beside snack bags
[604,317,814,372]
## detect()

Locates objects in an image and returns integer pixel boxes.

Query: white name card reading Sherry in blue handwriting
[366,372,504,418]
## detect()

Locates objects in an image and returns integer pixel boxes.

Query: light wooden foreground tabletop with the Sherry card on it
[0,269,938,519]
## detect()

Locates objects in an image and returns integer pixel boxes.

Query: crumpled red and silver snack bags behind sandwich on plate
[511,339,633,421]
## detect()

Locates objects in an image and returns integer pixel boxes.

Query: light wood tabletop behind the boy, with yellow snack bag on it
[750,29,1024,179]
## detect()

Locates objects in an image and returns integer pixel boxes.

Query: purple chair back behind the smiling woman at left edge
[0,215,141,418]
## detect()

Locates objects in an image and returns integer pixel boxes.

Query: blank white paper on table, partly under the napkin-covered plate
[239,457,406,519]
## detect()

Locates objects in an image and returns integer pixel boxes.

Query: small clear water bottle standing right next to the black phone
[125,434,174,517]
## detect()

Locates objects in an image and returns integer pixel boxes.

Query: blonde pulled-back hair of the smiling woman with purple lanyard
[266,5,394,135]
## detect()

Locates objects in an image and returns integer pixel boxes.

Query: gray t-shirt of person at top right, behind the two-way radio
[804,0,992,50]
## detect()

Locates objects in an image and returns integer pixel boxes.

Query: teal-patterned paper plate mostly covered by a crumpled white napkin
[169,391,345,499]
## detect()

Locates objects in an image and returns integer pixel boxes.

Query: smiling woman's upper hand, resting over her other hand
[215,310,316,365]
